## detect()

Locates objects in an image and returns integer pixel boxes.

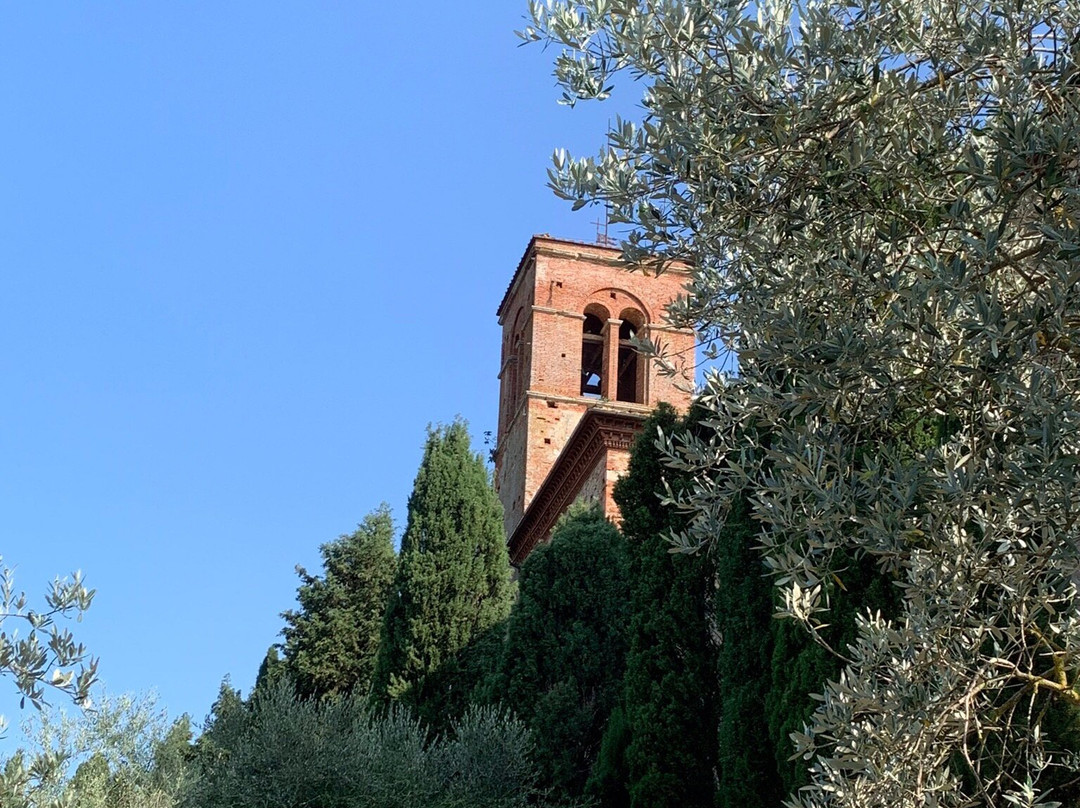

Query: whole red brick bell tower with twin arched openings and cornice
[495,235,694,566]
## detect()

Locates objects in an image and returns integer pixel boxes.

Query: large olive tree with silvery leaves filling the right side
[522,0,1080,808]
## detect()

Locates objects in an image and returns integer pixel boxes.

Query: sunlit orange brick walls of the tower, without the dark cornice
[495,235,693,557]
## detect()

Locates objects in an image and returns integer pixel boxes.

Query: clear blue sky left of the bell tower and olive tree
[0,0,635,721]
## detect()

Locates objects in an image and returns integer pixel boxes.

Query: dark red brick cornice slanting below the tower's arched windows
[508,405,646,567]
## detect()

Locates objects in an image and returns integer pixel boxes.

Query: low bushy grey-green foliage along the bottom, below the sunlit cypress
[185,681,540,808]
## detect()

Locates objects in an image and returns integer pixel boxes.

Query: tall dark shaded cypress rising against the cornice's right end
[606,405,726,808]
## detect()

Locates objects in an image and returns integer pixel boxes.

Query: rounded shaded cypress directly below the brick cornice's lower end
[501,509,626,796]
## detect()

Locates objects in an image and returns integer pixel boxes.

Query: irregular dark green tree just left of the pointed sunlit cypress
[282,503,396,697]
